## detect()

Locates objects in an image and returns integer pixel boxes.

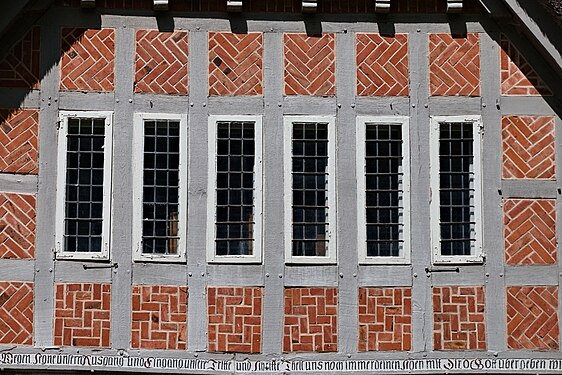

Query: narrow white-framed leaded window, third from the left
[210,116,261,262]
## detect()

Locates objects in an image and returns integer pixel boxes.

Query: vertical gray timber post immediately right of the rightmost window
[476,34,507,351]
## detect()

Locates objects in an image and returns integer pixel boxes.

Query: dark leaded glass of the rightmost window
[439,122,475,255]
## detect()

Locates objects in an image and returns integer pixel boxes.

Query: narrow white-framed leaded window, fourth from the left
[285,119,335,262]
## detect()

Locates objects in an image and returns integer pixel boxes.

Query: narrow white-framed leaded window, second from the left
[133,114,187,261]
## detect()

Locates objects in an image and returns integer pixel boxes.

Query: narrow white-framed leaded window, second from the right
[357,117,409,263]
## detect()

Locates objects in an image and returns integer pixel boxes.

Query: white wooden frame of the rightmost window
[430,115,485,264]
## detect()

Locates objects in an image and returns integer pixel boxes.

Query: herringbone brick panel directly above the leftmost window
[60,28,115,91]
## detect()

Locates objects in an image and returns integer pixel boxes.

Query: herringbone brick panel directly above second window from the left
[135,30,188,95]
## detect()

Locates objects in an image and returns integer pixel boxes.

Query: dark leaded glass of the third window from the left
[215,121,255,255]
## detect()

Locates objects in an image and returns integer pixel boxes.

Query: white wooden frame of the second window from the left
[132,113,188,263]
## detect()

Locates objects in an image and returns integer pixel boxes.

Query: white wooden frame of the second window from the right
[356,116,410,264]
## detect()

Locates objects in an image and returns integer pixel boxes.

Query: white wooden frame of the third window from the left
[207,115,263,263]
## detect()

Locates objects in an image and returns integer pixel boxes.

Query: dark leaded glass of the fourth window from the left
[292,123,328,256]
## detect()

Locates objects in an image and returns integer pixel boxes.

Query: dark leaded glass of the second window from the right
[365,124,404,257]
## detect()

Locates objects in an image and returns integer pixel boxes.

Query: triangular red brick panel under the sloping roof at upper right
[500,35,552,96]
